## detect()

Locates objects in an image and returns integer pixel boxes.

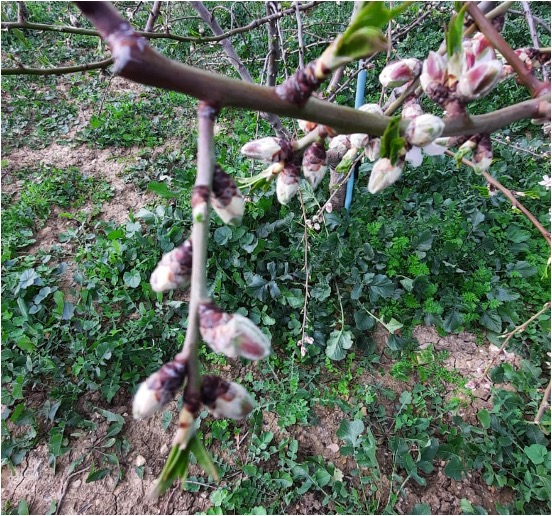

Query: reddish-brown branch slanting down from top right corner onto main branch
[468,2,550,98]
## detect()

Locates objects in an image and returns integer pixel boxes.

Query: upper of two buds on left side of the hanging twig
[150,238,193,292]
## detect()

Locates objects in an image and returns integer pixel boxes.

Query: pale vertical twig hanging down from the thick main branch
[180,102,218,401]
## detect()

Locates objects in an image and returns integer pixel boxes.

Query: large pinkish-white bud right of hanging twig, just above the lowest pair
[199,301,270,360]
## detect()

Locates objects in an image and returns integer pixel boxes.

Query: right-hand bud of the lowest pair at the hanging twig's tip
[201,375,255,419]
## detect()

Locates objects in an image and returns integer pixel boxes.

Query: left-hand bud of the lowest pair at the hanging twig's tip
[132,359,188,419]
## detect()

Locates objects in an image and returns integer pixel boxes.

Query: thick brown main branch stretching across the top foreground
[72,2,550,136]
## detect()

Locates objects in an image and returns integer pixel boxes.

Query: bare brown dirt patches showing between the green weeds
[2,80,515,514]
